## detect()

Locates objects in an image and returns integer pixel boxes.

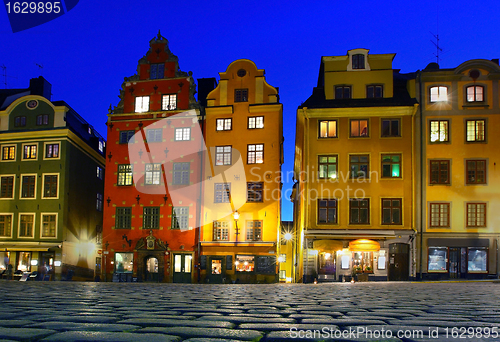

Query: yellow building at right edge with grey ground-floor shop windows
[417,59,500,279]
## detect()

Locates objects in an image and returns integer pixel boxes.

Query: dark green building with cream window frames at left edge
[0,77,105,280]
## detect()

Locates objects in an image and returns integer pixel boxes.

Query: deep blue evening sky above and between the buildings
[0,0,500,220]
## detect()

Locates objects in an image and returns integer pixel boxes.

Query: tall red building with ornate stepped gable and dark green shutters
[102,33,203,282]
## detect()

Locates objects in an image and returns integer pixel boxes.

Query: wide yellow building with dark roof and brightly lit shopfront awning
[292,49,418,282]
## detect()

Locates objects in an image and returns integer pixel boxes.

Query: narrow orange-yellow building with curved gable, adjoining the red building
[200,59,283,283]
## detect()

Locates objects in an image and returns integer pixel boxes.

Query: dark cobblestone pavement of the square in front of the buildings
[0,281,500,342]
